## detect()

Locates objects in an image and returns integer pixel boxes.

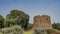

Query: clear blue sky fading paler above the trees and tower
[0,0,60,23]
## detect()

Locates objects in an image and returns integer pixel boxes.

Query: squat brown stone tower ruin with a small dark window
[33,15,52,29]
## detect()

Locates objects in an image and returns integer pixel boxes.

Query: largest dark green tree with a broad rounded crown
[6,10,29,29]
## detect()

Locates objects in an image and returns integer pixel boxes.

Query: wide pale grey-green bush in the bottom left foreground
[0,26,23,34]
